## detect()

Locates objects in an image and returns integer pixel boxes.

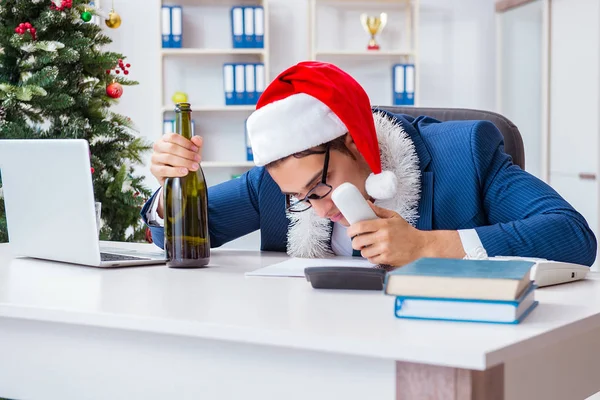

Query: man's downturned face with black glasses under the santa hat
[268,141,370,226]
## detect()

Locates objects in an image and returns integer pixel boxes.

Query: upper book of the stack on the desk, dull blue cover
[384,258,535,301]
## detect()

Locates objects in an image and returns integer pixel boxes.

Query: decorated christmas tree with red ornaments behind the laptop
[0,0,150,242]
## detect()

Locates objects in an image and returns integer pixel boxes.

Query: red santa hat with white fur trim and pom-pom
[247,61,396,199]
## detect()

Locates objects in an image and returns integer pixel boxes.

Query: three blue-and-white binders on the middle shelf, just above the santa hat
[223,63,266,106]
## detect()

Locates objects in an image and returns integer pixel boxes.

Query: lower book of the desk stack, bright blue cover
[394,283,538,324]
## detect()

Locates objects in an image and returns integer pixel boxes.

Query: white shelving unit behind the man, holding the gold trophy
[308,0,420,106]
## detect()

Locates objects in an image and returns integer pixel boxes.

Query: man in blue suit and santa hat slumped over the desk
[142,62,596,266]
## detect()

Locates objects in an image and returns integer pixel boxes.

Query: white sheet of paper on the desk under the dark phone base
[246,257,374,278]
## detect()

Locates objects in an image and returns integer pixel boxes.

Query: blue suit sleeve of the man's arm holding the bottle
[141,168,266,248]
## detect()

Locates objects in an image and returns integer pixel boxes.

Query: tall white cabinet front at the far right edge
[550,0,600,268]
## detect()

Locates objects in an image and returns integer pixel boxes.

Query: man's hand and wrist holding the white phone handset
[348,202,465,267]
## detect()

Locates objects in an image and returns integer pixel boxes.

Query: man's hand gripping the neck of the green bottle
[150,133,203,218]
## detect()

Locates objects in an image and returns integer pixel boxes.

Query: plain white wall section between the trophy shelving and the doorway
[420,0,496,110]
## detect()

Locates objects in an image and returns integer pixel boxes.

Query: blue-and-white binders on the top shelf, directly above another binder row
[231,6,265,49]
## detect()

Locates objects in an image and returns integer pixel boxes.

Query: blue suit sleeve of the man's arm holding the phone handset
[471,121,597,266]
